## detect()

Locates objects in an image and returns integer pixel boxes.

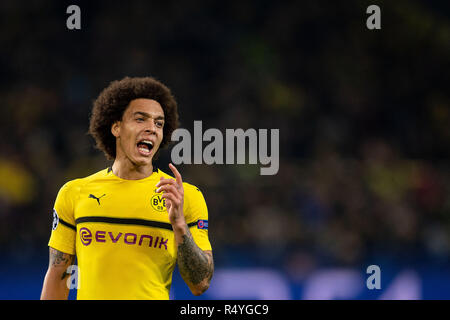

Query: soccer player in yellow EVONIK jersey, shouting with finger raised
[41,77,214,300]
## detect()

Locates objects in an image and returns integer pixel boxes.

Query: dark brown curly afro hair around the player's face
[88,77,179,160]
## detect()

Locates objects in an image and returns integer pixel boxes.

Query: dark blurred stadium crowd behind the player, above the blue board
[0,0,450,298]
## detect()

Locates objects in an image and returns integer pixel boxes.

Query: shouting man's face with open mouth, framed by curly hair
[111,98,164,166]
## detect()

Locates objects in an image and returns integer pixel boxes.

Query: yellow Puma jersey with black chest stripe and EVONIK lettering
[48,168,211,300]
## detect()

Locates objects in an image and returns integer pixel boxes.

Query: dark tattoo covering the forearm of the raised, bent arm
[178,226,214,285]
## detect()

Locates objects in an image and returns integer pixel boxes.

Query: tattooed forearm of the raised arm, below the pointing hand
[174,224,214,295]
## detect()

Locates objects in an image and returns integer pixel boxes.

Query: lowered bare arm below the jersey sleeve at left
[41,247,75,300]
